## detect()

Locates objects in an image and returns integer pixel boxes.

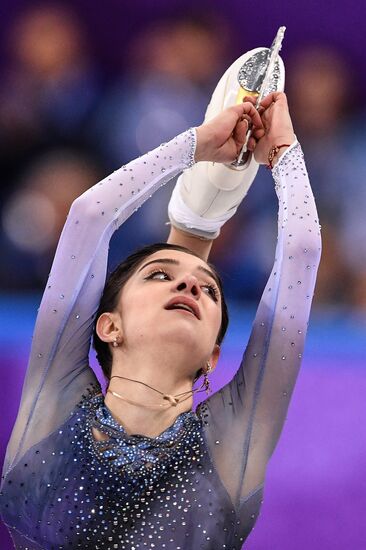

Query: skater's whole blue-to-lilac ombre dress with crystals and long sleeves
[0,129,320,550]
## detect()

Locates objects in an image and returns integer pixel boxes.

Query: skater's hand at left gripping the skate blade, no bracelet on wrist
[195,101,264,163]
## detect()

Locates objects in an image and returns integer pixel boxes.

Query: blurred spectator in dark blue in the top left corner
[0,4,100,203]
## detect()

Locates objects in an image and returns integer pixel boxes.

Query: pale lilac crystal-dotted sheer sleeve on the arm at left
[4,129,196,474]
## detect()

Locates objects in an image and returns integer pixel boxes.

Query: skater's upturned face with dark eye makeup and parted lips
[116,249,221,368]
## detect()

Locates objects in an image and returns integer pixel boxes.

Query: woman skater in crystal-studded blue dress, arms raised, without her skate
[0,52,320,550]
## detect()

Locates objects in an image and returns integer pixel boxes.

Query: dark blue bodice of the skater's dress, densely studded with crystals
[1,388,262,550]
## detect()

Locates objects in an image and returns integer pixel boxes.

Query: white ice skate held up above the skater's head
[168,31,285,239]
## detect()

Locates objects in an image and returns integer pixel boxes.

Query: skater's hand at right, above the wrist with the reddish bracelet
[245,92,296,164]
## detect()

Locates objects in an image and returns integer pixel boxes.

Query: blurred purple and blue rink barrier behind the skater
[0,299,366,550]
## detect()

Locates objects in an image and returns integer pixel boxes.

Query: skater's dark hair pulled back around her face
[93,243,229,380]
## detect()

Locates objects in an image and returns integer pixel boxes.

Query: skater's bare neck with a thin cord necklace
[105,350,198,437]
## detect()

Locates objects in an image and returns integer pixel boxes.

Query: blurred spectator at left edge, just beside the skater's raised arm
[0,150,101,290]
